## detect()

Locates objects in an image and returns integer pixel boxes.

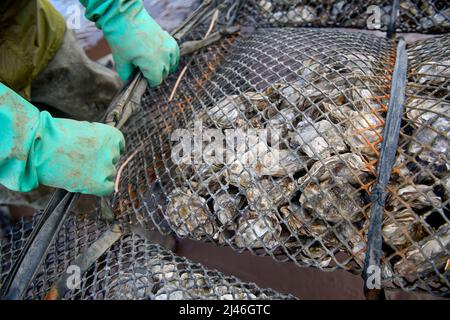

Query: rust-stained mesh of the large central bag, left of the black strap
[114,29,392,268]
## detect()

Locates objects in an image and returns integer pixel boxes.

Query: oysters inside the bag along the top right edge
[255,0,450,32]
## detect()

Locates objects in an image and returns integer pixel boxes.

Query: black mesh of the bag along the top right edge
[241,0,450,33]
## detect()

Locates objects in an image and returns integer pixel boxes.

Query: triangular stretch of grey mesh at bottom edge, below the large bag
[57,235,293,300]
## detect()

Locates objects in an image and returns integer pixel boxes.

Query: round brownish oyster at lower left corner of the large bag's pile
[165,189,217,240]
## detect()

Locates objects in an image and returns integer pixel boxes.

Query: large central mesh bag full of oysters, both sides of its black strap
[110,19,449,295]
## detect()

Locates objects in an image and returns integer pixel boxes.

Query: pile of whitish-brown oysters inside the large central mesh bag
[165,35,449,280]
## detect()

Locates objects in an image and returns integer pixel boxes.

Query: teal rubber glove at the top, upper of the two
[80,0,179,87]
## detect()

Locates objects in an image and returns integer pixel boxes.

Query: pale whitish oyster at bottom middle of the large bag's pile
[235,211,281,250]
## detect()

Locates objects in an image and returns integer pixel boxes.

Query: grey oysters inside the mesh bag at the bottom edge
[107,254,273,300]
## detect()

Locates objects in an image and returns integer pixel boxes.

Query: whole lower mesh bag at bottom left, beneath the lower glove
[0,213,294,300]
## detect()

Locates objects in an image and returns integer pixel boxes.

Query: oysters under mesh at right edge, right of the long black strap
[383,36,450,275]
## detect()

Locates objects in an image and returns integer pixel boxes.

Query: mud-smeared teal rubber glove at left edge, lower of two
[0,84,125,196]
